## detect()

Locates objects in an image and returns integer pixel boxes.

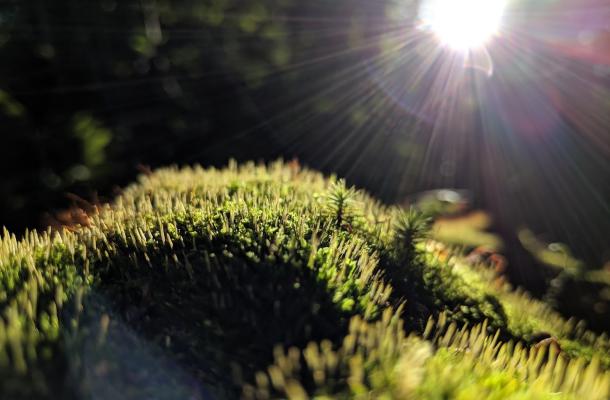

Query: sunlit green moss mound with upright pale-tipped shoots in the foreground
[0,163,610,399]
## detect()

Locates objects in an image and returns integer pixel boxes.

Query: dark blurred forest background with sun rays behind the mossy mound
[0,0,610,329]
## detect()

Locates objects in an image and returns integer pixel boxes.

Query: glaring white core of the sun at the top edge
[420,0,506,51]
